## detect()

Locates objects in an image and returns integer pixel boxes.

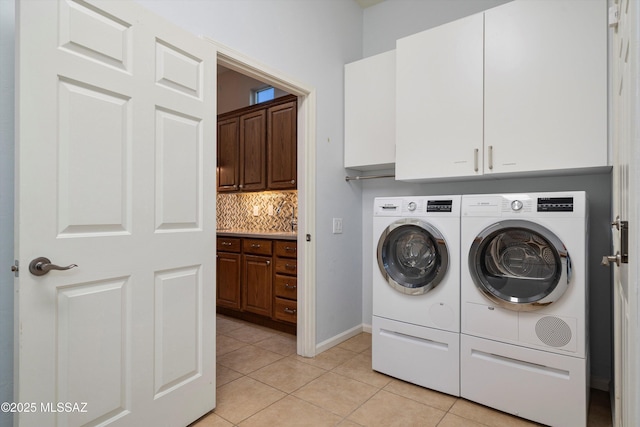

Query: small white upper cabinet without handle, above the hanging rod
[344,51,396,170]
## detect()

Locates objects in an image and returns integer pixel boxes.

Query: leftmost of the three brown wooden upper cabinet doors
[217,117,240,191]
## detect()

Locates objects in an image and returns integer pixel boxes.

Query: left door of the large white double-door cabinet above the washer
[396,14,483,181]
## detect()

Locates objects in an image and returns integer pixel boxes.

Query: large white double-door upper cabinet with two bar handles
[396,0,608,181]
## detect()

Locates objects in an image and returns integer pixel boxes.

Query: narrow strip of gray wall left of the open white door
[0,0,15,426]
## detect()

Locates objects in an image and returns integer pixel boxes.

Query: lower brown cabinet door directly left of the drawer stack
[242,255,272,317]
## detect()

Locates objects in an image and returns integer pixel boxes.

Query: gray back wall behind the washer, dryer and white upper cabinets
[358,0,613,389]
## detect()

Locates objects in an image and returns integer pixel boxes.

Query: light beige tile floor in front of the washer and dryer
[191,316,612,427]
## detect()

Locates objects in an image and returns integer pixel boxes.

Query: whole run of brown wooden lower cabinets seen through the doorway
[216,237,297,334]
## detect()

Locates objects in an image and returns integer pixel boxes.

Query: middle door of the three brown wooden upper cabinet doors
[240,110,267,191]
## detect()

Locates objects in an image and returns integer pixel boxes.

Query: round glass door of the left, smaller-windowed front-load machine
[378,219,449,295]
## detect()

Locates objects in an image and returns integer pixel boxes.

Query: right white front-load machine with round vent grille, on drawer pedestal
[460,192,589,427]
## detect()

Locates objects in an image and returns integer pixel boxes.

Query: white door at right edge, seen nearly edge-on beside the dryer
[603,0,640,427]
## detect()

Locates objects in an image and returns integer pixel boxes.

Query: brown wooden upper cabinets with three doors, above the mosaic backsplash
[217,95,298,192]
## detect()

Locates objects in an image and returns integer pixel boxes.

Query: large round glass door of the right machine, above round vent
[469,220,571,311]
